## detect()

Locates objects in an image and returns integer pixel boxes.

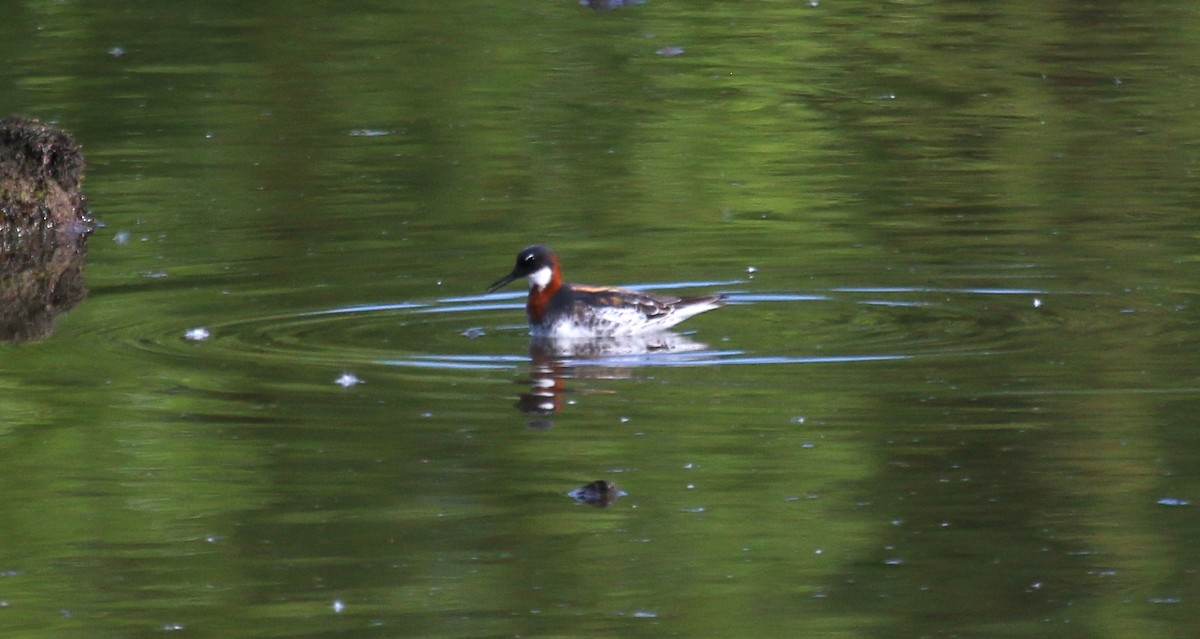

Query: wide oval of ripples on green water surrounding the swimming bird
[82,280,1048,377]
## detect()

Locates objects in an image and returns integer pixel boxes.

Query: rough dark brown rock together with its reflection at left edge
[0,117,95,341]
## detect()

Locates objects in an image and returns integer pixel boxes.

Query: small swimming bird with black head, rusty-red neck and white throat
[487,244,725,338]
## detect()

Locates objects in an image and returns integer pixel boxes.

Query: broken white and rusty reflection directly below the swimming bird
[516,332,708,429]
